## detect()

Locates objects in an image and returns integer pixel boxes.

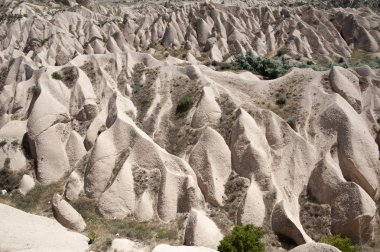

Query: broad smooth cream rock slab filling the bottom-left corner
[0,204,88,252]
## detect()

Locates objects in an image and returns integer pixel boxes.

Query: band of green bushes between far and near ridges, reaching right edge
[232,50,380,79]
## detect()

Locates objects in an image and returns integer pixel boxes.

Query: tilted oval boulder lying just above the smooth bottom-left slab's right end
[52,193,86,232]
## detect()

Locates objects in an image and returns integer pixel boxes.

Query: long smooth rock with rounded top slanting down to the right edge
[320,95,379,197]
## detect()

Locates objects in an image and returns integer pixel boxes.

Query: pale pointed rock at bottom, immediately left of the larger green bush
[185,209,223,249]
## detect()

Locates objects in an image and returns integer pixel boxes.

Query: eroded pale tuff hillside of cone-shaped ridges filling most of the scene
[0,1,380,251]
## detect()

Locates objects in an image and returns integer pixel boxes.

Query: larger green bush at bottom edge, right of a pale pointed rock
[218,224,265,252]
